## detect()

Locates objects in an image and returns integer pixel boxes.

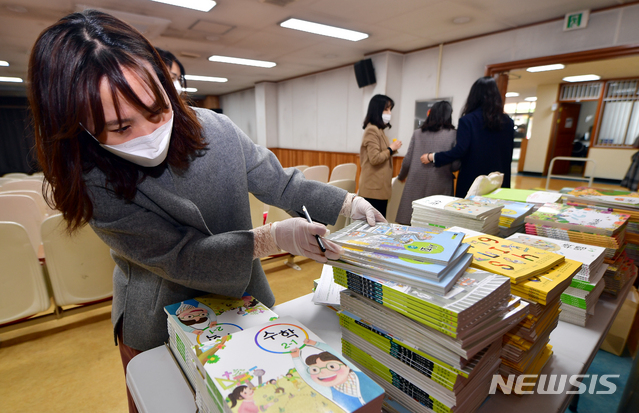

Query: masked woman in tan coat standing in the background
[359,95,402,216]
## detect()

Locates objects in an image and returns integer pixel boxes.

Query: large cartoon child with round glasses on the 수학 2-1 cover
[291,339,375,412]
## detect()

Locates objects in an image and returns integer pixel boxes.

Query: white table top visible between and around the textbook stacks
[127,278,634,413]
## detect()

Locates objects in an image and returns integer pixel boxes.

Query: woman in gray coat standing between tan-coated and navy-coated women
[395,101,461,225]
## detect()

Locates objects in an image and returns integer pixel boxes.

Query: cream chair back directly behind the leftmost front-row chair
[0,192,44,255]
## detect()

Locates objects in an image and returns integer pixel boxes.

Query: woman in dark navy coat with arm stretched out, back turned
[421,76,515,198]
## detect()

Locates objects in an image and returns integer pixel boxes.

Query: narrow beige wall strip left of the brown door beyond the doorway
[524,84,559,173]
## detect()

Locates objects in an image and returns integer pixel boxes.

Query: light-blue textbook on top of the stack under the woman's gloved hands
[326,221,464,264]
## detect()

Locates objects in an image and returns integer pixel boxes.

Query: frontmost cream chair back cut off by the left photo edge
[0,222,51,324]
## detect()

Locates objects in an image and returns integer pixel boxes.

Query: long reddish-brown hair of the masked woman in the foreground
[28,10,206,232]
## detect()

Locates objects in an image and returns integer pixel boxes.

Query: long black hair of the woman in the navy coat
[462,76,504,131]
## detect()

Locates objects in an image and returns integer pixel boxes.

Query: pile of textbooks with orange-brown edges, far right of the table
[526,203,630,260]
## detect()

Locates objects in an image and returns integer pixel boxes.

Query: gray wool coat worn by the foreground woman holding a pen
[85,108,346,351]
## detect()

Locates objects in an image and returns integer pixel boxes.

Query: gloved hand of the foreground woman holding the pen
[271,218,342,262]
